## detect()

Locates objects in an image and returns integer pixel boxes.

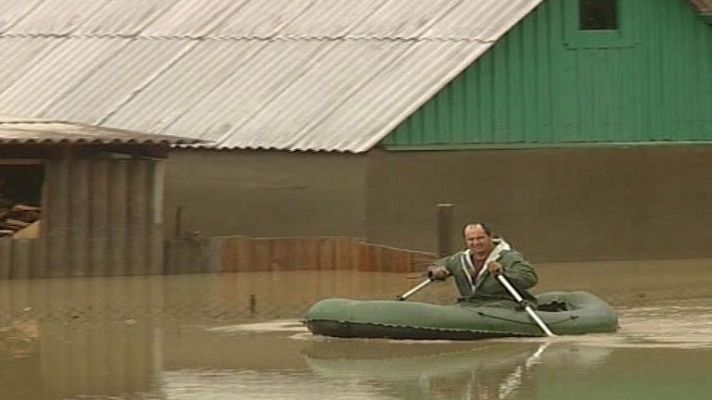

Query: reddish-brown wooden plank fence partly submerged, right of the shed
[165,236,435,273]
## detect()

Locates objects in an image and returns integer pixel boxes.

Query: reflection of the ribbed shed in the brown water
[0,279,162,400]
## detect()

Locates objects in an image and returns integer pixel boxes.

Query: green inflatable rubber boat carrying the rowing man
[304,292,618,340]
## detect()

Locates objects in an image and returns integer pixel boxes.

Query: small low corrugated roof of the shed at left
[0,115,202,145]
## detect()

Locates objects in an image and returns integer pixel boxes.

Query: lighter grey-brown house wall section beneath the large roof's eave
[165,150,366,238]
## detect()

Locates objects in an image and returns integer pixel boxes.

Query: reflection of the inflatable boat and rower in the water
[305,339,610,399]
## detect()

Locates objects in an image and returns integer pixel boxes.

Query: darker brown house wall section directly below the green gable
[366,146,712,261]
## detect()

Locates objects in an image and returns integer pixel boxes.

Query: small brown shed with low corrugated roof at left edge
[0,117,203,279]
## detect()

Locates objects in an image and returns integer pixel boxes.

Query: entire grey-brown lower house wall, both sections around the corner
[164,146,712,262]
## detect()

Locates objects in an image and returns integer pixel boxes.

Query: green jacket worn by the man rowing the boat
[435,239,538,307]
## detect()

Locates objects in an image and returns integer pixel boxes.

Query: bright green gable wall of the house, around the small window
[382,0,712,149]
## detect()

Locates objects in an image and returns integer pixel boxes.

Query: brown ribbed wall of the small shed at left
[0,152,164,279]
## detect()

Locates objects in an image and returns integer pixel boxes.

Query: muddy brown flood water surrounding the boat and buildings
[0,260,712,400]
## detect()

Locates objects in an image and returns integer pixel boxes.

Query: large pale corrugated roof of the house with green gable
[0,0,542,152]
